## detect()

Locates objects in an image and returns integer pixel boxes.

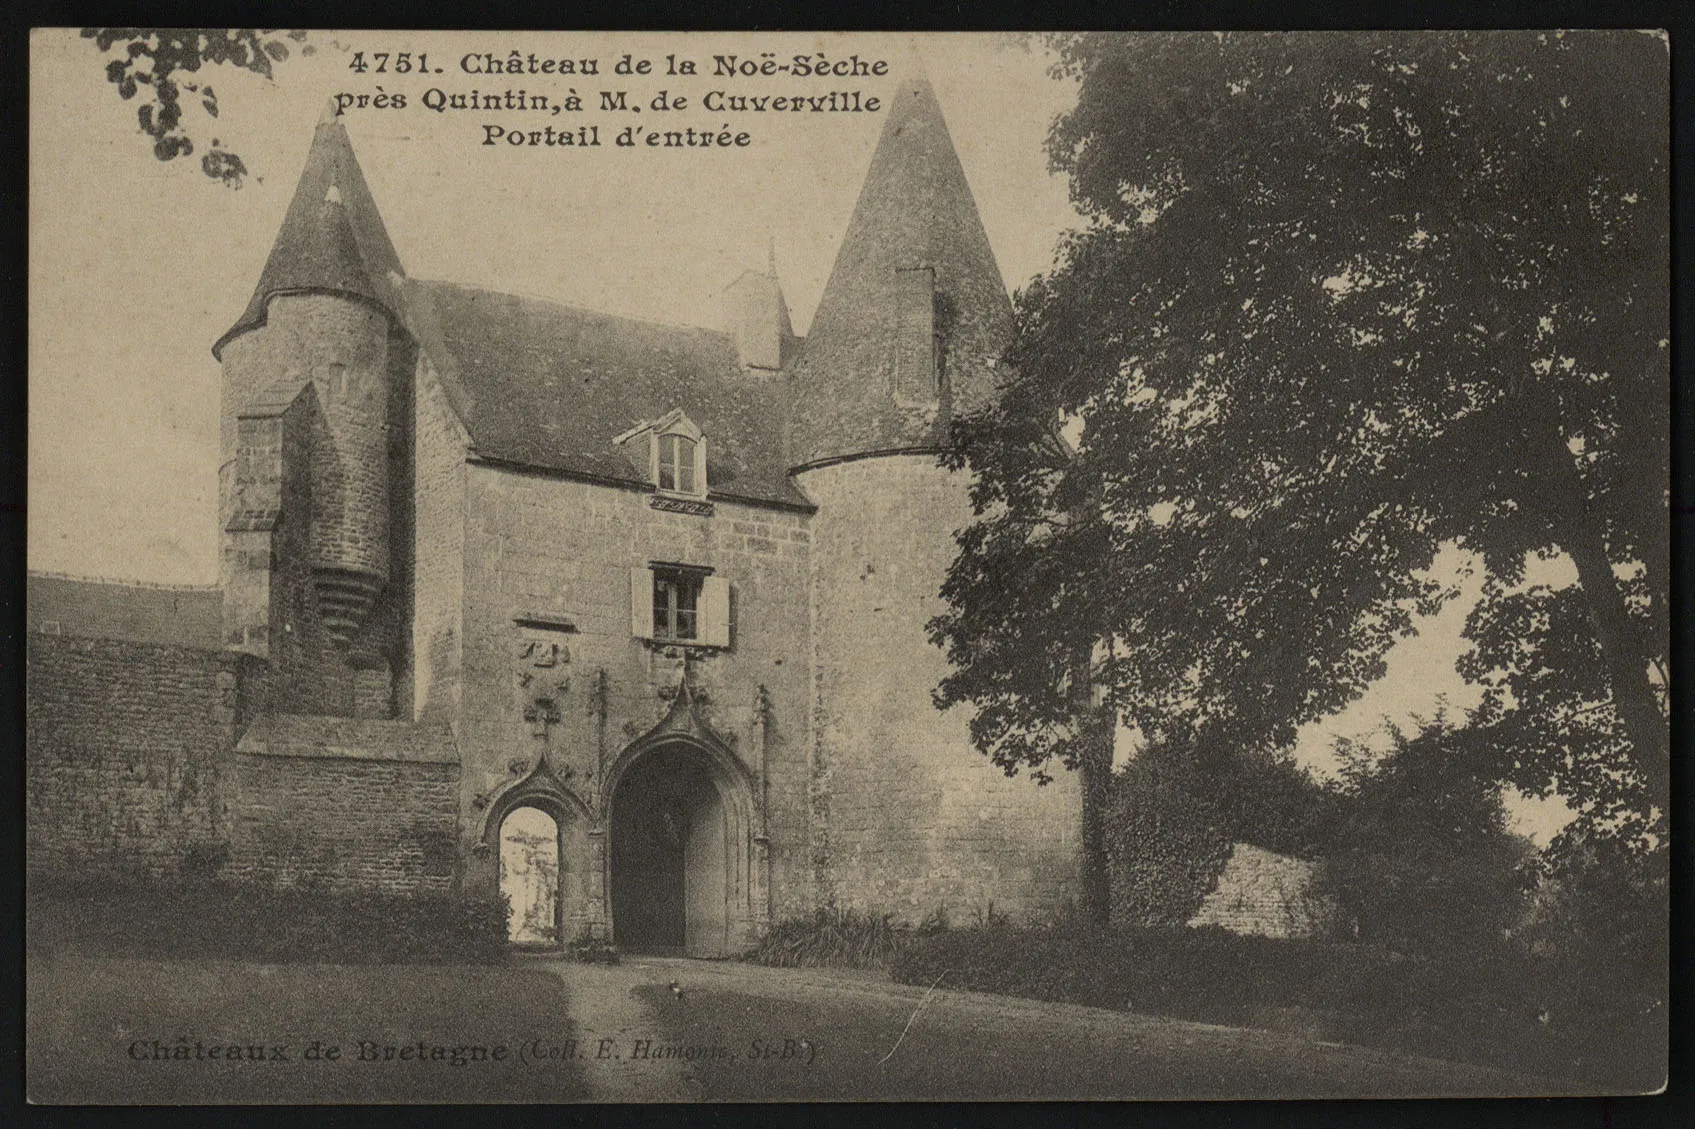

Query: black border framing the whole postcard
[0,0,1695,1129]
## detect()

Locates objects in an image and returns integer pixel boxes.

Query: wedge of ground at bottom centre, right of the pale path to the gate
[636,970,1534,1102]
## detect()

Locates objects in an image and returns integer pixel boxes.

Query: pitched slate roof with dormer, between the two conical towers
[405,280,810,509]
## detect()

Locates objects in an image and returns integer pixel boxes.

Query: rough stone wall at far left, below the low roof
[25,634,242,878]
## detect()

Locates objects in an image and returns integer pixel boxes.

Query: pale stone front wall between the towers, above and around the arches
[459,461,812,915]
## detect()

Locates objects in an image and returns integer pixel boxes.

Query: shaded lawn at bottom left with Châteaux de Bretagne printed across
[25,953,588,1104]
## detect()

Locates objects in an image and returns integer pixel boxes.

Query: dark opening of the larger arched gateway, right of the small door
[609,742,746,956]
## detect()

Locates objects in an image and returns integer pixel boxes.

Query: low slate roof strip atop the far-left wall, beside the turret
[24,573,224,651]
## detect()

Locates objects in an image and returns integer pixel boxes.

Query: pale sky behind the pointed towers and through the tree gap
[29,31,1559,839]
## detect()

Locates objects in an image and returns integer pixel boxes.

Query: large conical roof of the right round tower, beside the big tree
[788,73,1012,466]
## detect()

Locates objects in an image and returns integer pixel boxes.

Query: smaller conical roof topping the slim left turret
[212,114,405,356]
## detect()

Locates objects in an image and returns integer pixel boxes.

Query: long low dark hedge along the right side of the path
[890,922,1664,1090]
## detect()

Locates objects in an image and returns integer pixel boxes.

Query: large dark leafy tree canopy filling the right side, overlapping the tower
[931,32,1670,844]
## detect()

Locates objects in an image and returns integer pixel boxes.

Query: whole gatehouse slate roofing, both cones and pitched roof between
[214,76,1012,491]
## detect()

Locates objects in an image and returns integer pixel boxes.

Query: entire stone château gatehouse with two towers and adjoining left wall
[29,78,1080,956]
